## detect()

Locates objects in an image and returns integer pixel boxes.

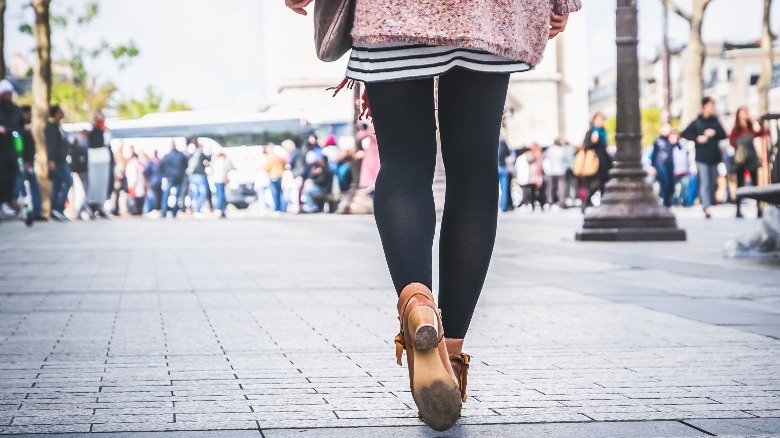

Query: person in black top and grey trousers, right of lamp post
[682,97,728,219]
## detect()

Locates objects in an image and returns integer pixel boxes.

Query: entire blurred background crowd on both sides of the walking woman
[0,74,767,221]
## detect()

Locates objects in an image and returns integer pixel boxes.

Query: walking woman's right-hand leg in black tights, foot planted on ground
[436,69,509,338]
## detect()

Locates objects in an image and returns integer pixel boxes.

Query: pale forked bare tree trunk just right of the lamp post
[661,0,712,124]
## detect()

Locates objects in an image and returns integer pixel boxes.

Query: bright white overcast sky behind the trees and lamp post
[6,0,780,110]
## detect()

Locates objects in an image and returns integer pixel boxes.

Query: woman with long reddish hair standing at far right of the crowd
[729,106,766,218]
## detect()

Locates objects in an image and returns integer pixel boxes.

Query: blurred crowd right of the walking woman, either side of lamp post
[498,98,768,218]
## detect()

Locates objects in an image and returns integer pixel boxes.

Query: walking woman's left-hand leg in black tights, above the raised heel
[366,79,438,294]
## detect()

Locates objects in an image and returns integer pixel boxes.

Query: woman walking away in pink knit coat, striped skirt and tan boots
[286,0,581,430]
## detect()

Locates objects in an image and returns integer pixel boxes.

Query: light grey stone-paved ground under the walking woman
[0,209,780,438]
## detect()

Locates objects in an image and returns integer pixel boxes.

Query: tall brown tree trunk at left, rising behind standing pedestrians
[32,0,51,215]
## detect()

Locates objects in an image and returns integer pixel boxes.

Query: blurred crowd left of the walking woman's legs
[0,76,379,222]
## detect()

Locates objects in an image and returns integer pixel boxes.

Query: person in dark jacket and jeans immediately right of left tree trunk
[46,105,73,222]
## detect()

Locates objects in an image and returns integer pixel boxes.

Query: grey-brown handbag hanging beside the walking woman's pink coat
[314,0,355,62]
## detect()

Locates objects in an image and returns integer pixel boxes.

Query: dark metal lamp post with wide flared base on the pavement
[577,0,686,242]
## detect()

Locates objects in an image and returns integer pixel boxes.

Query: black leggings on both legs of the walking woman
[366,69,509,338]
